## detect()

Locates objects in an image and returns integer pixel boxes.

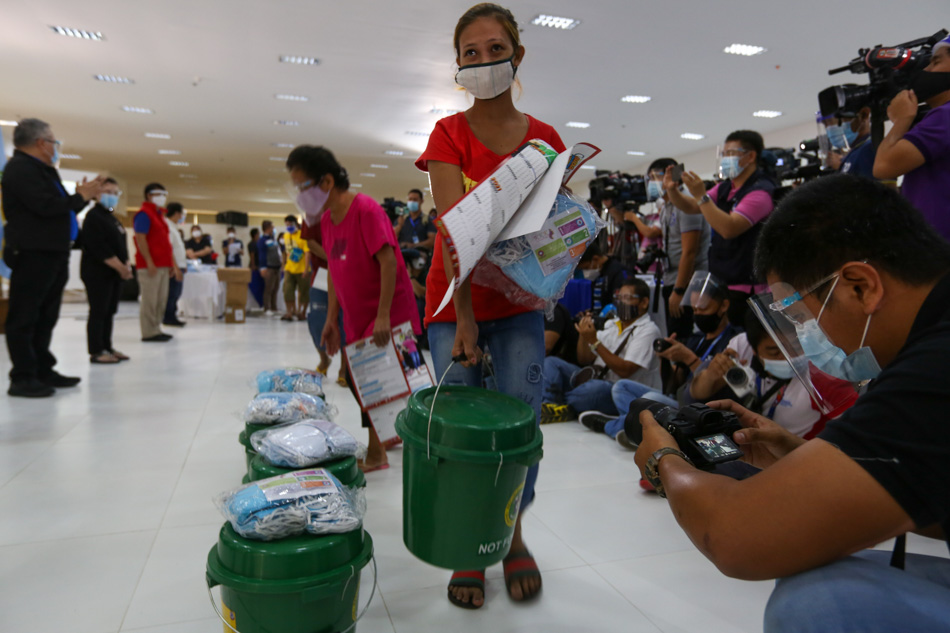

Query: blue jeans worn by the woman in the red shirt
[429,312,544,510]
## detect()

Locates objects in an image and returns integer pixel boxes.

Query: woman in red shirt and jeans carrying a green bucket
[416,3,564,609]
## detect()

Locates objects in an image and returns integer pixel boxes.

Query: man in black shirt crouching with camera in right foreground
[636,175,950,633]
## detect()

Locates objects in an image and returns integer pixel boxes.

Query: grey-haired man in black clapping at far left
[0,119,102,398]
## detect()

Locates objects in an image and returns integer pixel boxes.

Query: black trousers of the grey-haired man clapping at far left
[6,251,69,382]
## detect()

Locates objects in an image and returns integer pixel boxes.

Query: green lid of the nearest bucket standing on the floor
[216,523,364,580]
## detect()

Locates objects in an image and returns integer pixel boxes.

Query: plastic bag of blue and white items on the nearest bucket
[214,469,366,541]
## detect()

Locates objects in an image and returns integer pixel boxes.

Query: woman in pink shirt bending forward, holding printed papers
[287,145,422,472]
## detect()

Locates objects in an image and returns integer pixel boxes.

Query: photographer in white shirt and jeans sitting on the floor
[541,278,660,424]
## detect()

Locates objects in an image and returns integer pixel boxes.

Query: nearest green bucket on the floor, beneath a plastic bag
[207,523,373,633]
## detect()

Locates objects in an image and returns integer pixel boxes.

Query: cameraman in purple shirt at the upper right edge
[874,37,950,239]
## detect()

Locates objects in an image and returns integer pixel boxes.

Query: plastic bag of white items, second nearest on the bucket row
[251,420,366,468]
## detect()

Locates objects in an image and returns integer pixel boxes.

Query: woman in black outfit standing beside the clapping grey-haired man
[79,178,132,364]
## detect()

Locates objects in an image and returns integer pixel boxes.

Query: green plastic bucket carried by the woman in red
[396,386,542,569]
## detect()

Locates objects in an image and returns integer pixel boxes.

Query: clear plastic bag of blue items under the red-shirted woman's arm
[473,189,605,311]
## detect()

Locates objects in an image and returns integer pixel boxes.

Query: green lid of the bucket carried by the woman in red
[401,385,540,453]
